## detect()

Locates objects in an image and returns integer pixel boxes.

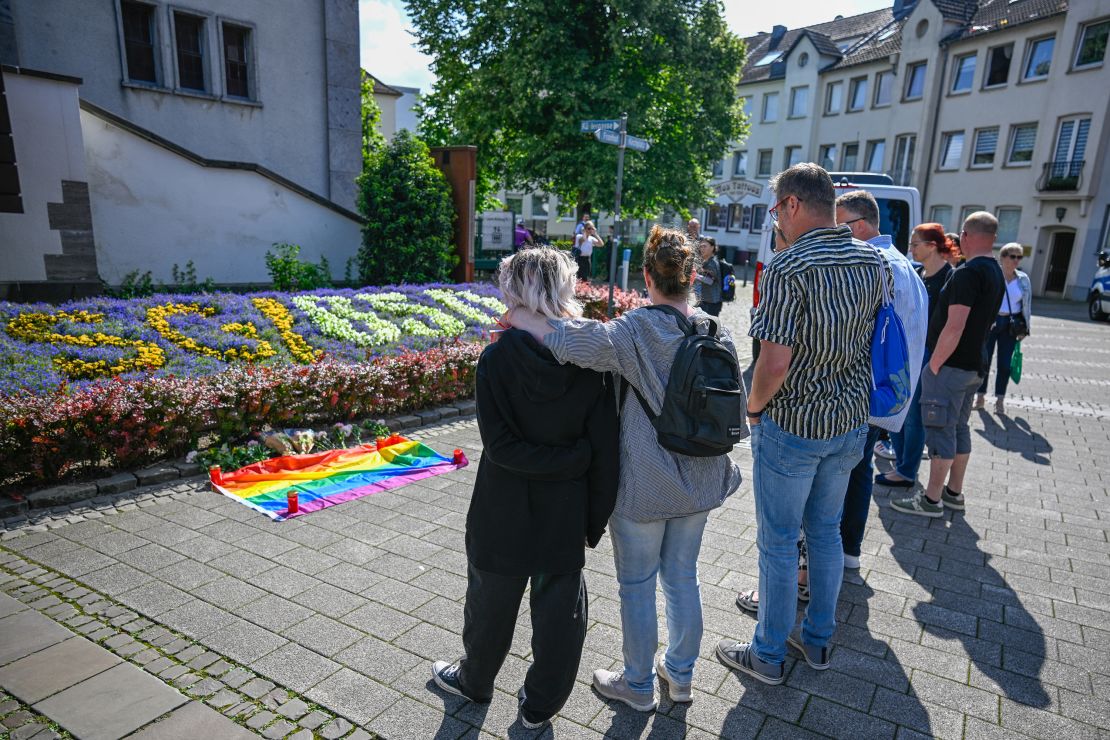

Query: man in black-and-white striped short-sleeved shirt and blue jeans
[717,163,894,685]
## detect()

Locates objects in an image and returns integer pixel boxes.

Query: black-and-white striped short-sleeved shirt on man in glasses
[748,226,894,439]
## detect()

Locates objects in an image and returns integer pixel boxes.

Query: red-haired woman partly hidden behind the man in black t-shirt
[875,223,960,488]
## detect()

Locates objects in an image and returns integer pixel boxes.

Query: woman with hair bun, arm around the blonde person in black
[509,225,748,711]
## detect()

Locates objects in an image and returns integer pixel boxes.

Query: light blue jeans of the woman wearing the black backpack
[609,511,710,693]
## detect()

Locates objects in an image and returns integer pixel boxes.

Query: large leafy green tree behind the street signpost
[406,0,747,216]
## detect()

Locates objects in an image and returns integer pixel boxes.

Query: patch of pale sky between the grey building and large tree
[359,0,435,92]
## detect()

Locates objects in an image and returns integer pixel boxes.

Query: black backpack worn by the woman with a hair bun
[622,305,747,457]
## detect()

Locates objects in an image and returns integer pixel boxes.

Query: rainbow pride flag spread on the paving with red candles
[209,434,467,521]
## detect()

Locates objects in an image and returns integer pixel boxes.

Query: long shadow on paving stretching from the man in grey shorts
[879,501,1051,708]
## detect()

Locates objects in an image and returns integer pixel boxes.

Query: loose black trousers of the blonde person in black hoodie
[458,564,589,722]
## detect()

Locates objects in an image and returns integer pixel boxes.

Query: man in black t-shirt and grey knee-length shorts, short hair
[890,211,1006,517]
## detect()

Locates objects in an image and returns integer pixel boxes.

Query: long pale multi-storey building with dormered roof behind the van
[703,0,1110,300]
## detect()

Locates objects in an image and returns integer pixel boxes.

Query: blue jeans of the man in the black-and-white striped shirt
[751,414,867,663]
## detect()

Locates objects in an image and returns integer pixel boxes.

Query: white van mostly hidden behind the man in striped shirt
[751,172,923,357]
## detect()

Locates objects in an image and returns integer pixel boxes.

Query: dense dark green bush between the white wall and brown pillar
[357,131,458,285]
